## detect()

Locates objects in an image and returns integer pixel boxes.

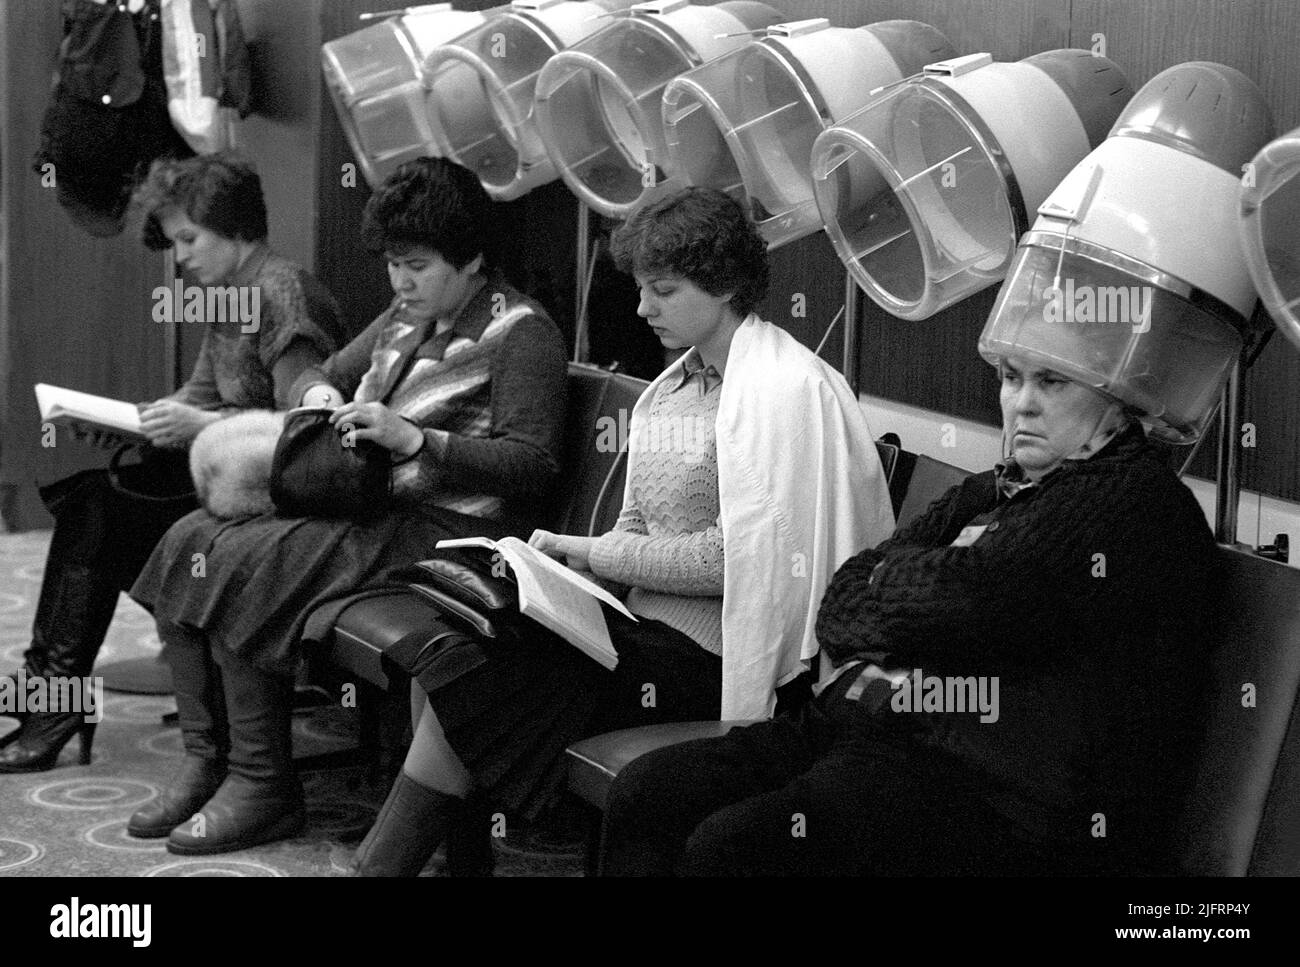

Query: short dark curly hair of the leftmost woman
[131,151,267,248]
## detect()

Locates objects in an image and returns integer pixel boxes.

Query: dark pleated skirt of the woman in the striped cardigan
[131,509,502,676]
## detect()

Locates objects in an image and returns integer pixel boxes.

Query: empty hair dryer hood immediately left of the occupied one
[813,49,1132,320]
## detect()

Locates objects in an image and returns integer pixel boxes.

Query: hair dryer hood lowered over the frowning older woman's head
[979,62,1273,443]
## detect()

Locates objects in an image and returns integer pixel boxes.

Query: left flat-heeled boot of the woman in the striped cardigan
[126,626,230,840]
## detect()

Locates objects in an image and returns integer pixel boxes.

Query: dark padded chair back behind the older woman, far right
[1179,547,1300,876]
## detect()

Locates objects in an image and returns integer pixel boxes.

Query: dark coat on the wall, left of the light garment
[33,0,194,237]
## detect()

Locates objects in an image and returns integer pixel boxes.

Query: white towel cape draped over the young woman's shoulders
[628,315,894,719]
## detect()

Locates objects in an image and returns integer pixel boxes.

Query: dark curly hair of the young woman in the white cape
[611,187,770,317]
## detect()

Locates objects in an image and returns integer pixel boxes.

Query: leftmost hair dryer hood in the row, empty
[321,4,485,188]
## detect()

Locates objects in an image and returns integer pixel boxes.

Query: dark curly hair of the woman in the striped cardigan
[361,157,497,269]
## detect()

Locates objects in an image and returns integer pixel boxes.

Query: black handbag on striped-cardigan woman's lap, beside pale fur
[270,408,393,520]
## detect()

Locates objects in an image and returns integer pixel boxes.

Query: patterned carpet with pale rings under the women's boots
[0,532,582,876]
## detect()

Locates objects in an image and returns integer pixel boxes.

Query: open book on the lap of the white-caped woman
[436,537,637,671]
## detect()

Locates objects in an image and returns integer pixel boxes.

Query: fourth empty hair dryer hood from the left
[663,18,956,248]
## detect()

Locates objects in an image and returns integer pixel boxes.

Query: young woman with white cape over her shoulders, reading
[354,188,893,876]
